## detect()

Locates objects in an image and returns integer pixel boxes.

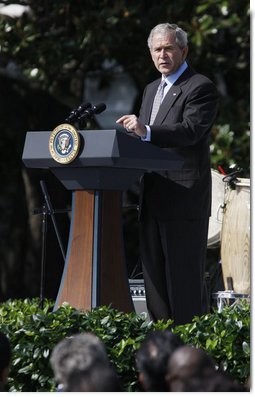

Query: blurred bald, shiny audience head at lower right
[166,346,215,392]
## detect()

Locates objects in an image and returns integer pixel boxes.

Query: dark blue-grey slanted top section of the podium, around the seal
[22,130,183,170]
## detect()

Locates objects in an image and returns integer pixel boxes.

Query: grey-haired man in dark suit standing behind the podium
[117,23,218,325]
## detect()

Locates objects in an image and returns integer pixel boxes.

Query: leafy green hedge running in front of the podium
[0,299,250,392]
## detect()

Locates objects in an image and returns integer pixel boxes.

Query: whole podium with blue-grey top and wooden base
[22,130,183,312]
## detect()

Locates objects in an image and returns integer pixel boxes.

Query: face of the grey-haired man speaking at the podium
[150,31,188,76]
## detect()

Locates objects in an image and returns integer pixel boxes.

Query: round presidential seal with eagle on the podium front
[49,124,80,164]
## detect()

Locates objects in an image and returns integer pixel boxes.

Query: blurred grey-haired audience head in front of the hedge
[50,333,117,391]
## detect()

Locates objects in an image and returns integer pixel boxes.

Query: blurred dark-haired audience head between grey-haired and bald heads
[136,330,183,392]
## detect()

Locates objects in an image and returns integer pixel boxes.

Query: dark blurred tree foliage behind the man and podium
[0,0,250,300]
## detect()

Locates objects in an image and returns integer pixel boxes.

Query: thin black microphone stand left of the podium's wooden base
[34,180,68,309]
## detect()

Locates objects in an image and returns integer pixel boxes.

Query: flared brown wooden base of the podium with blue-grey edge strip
[54,190,134,312]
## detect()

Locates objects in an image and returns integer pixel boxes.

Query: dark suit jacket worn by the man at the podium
[139,67,218,220]
